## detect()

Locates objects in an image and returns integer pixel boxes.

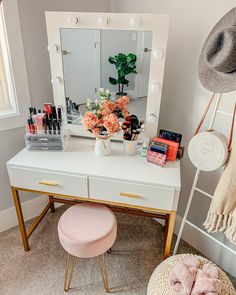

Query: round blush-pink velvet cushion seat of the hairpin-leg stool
[58,203,117,258]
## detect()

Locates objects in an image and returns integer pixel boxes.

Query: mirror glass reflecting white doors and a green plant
[60,28,152,124]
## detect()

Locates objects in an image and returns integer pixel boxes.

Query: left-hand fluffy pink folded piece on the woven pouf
[169,255,200,295]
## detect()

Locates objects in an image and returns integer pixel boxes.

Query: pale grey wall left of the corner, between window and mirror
[0,0,110,213]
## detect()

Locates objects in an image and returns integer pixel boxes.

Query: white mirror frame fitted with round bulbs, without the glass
[45,11,169,140]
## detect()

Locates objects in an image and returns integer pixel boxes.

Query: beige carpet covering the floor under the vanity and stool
[0,206,236,295]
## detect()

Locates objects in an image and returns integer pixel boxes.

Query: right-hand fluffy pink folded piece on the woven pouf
[191,264,221,295]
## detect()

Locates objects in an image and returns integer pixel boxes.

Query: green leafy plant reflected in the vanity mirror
[108,53,137,95]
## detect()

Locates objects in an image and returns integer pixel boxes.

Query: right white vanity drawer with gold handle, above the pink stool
[89,177,175,211]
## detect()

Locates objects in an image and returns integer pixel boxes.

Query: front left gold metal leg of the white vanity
[11,187,30,251]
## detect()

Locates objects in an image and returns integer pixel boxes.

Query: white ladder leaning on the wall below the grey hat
[173,93,236,255]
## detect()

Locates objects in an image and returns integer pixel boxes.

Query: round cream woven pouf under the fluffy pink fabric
[147,254,236,295]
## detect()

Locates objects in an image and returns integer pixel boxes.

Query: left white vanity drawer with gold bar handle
[8,167,88,198]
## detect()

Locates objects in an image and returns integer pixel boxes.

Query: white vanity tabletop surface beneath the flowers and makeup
[7,137,181,190]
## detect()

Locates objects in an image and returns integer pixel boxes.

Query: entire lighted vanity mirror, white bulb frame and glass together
[46,12,169,139]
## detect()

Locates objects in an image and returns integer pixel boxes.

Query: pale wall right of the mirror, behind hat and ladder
[111,0,236,274]
